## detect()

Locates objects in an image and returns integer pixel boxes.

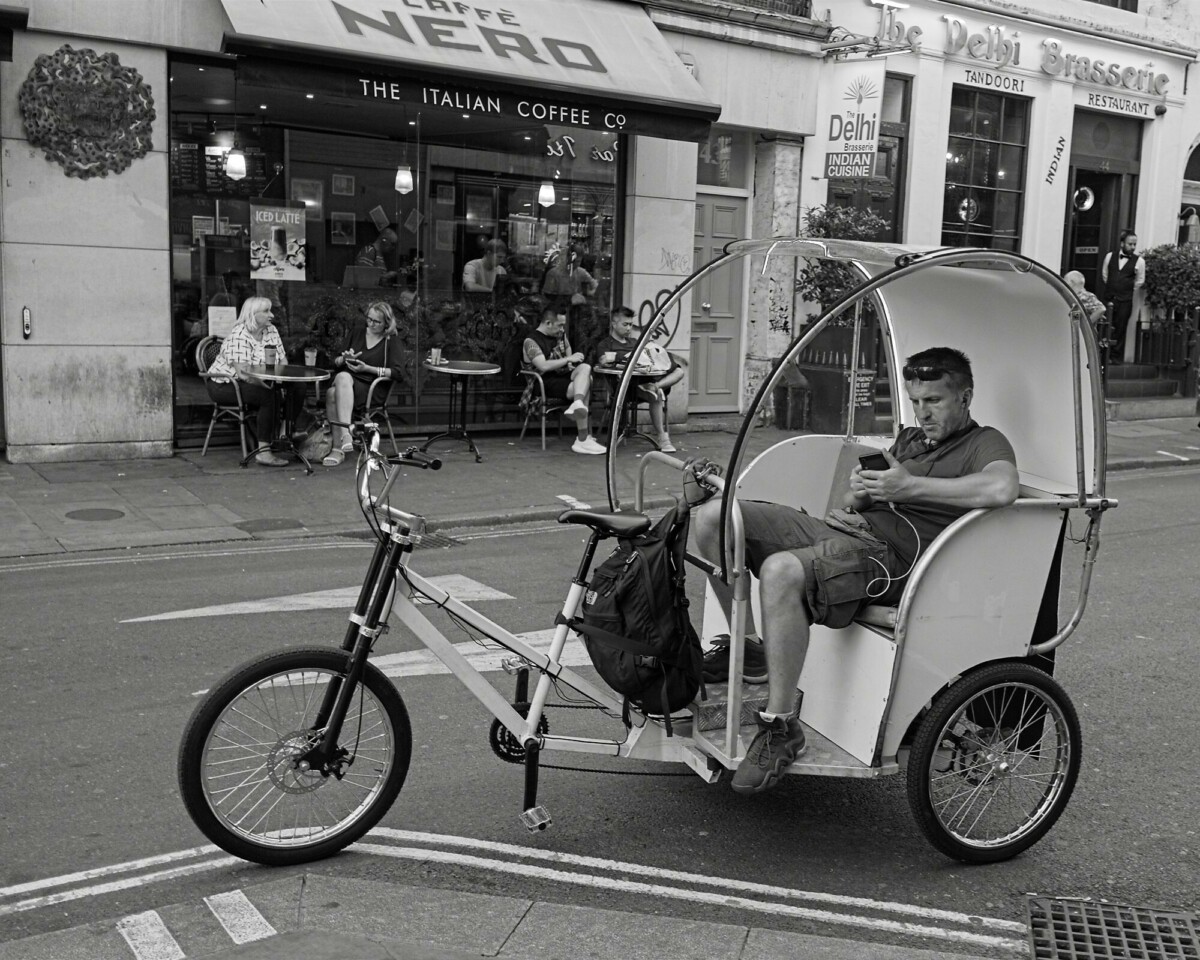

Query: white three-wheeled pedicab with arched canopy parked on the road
[178,239,1116,865]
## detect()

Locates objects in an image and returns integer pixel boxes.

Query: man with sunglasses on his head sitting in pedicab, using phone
[694,347,1019,793]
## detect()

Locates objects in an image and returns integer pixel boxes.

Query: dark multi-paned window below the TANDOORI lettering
[942,86,1030,251]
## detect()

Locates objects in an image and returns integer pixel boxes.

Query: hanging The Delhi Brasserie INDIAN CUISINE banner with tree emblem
[818,60,883,179]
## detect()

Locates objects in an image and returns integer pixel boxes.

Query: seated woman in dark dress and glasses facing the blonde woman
[322,300,404,467]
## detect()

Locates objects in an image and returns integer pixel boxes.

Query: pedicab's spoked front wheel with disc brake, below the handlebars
[178,648,413,866]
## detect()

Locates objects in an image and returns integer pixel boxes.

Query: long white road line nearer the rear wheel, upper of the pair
[372,827,1025,934]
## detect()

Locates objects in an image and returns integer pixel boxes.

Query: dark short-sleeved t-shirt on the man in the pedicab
[859,421,1016,568]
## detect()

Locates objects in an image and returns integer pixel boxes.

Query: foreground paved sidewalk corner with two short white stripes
[0,870,1025,960]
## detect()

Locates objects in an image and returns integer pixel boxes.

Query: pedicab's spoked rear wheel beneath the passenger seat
[908,664,1080,863]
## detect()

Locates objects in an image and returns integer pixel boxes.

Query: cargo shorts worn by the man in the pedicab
[738,500,904,628]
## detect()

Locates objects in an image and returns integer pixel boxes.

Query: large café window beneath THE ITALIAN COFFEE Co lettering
[170,58,623,445]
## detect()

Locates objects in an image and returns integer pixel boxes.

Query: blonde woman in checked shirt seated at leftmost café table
[208,296,305,467]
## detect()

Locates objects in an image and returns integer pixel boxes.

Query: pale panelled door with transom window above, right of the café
[688,194,746,413]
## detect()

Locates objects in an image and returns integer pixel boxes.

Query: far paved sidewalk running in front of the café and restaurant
[0,418,1200,557]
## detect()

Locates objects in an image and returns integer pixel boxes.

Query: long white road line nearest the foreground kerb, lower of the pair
[350,844,1026,953]
